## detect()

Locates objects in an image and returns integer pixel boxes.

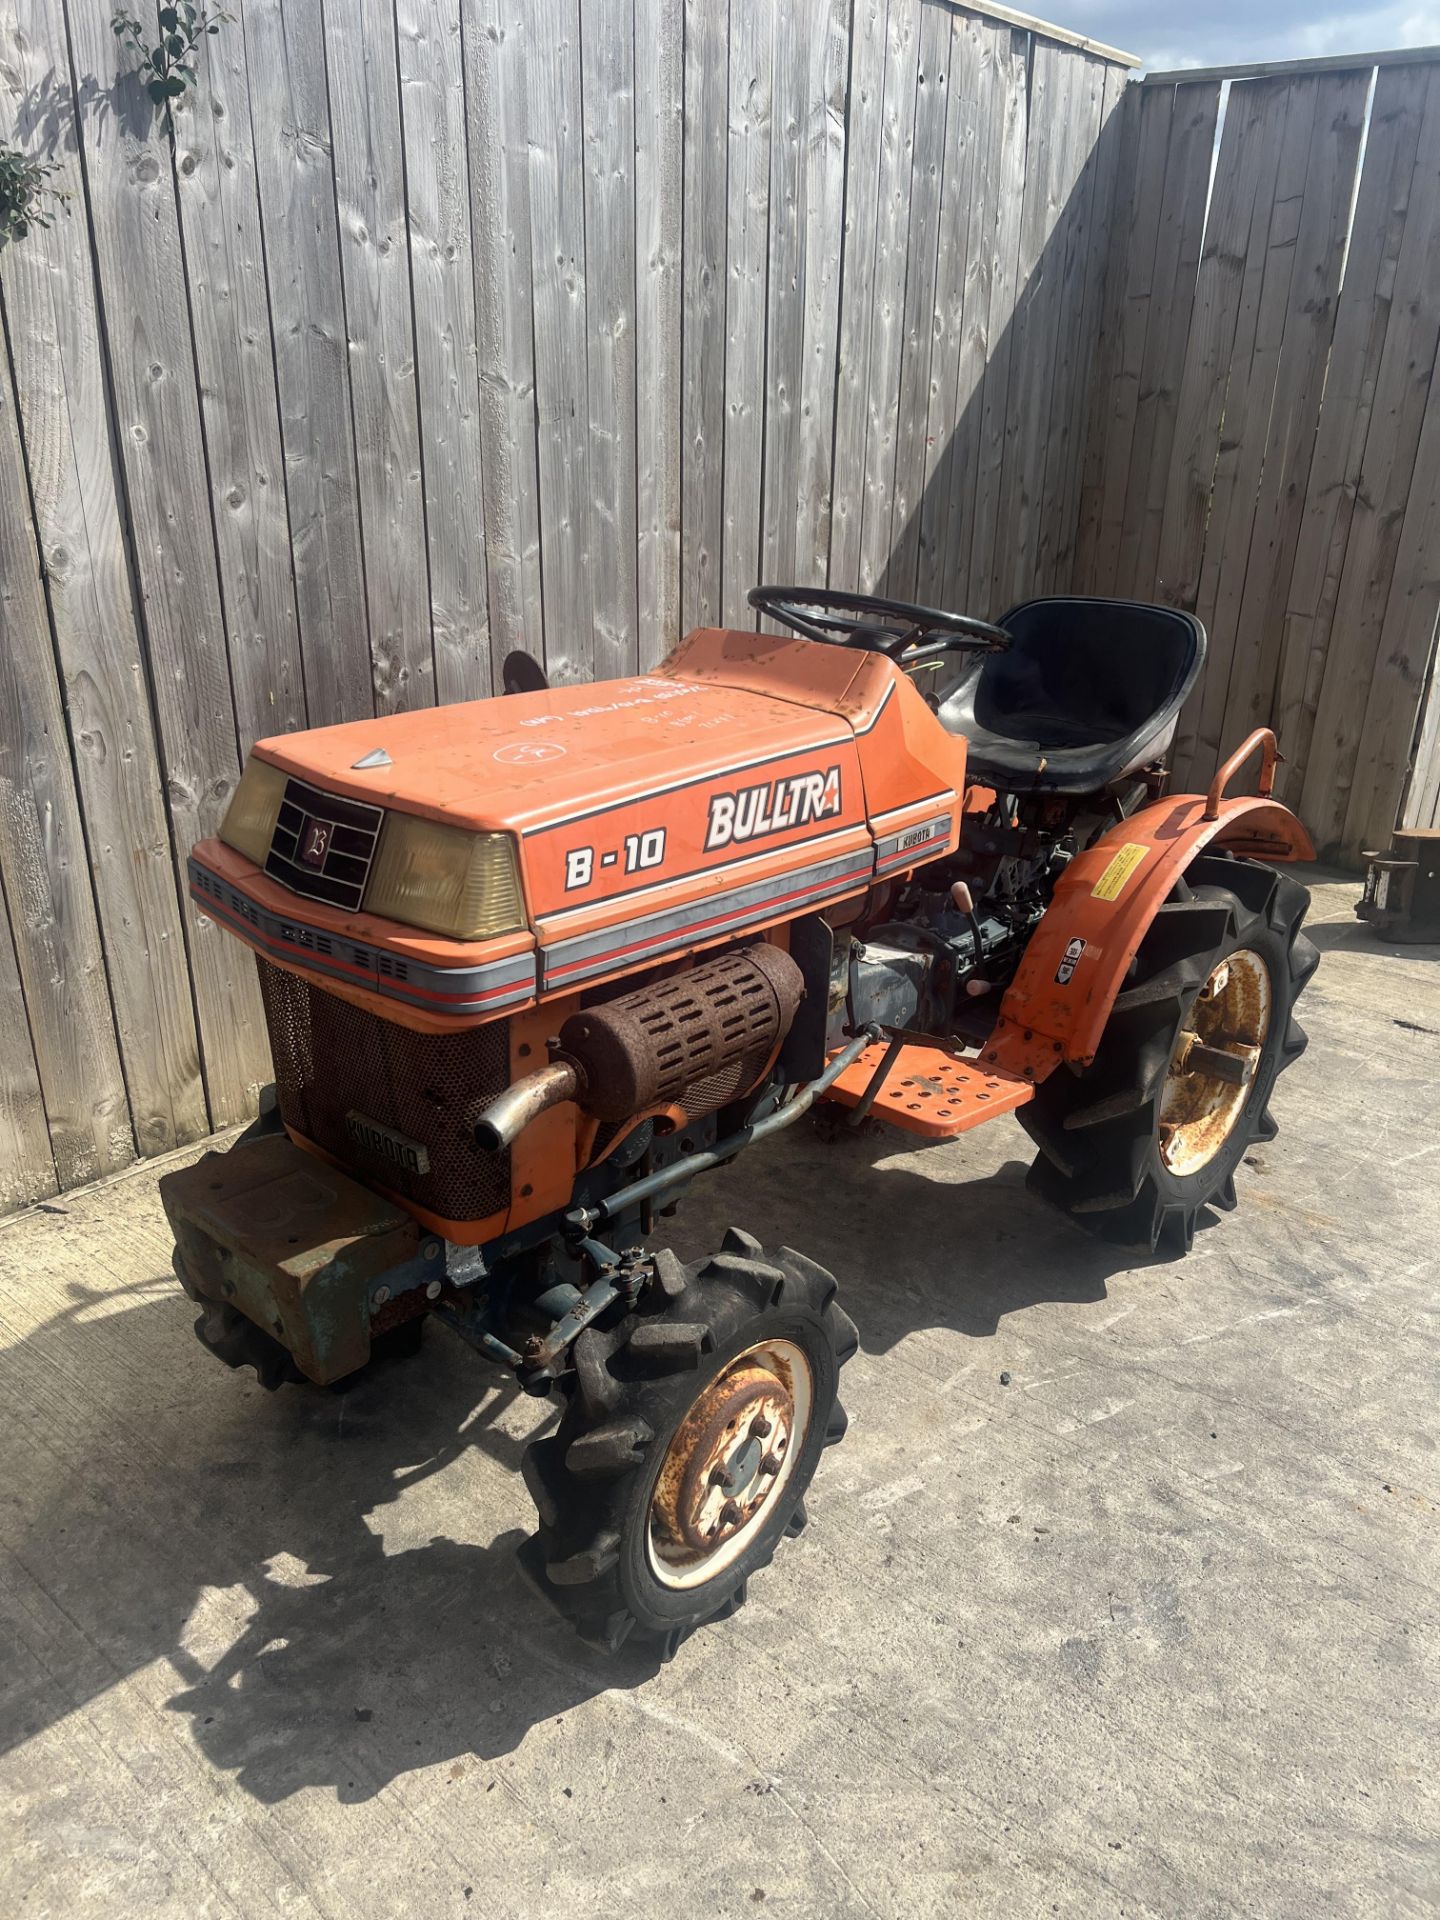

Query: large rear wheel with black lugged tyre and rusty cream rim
[1018,854,1319,1254]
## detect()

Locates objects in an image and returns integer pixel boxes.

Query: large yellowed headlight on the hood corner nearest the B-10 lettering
[365,812,524,941]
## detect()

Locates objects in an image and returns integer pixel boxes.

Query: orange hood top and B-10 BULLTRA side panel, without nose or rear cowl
[243,674,898,987]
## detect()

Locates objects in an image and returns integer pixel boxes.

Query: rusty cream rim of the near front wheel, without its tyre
[647,1340,814,1588]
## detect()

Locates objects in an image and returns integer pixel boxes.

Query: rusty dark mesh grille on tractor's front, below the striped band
[255,956,511,1219]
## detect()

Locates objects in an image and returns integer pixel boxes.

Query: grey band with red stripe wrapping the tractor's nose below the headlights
[188,856,536,1014]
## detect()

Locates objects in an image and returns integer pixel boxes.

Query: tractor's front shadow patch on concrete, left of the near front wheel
[0,1277,659,1805]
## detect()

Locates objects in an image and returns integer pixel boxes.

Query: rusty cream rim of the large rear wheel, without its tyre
[1160,947,1271,1177]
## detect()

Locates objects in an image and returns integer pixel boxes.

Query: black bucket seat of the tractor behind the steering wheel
[939,595,1206,793]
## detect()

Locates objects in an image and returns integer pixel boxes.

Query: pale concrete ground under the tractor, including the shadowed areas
[0,881,1440,1920]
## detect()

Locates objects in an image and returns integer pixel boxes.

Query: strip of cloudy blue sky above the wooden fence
[1059,0,1440,69]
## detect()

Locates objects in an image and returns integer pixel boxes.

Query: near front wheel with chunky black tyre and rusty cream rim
[520,1229,858,1659]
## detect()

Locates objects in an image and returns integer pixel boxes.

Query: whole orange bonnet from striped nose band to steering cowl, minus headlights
[192,630,964,1018]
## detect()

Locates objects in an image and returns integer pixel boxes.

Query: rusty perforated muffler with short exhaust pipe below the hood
[474,941,804,1152]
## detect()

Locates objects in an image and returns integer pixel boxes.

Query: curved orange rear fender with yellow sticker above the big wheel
[985,793,1315,1083]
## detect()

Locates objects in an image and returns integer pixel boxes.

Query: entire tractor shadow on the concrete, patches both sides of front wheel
[0,1127,1175,1818]
